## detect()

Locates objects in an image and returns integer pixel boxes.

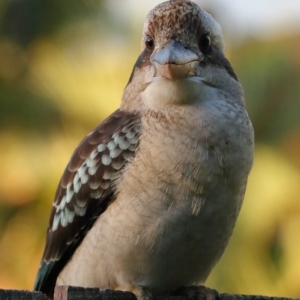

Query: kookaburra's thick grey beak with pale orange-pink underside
[151,40,200,79]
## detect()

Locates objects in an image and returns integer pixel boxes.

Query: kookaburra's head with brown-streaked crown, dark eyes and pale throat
[123,0,243,106]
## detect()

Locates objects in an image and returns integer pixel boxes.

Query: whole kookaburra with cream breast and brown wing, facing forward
[34,0,254,300]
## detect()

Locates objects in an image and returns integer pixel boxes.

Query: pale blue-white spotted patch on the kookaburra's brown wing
[52,122,139,231]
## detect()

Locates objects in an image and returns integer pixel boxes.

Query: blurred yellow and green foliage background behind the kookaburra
[0,0,300,297]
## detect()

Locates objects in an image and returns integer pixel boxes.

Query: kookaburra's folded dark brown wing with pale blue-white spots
[34,110,141,295]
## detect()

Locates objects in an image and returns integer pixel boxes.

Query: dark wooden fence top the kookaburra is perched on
[0,286,300,300]
